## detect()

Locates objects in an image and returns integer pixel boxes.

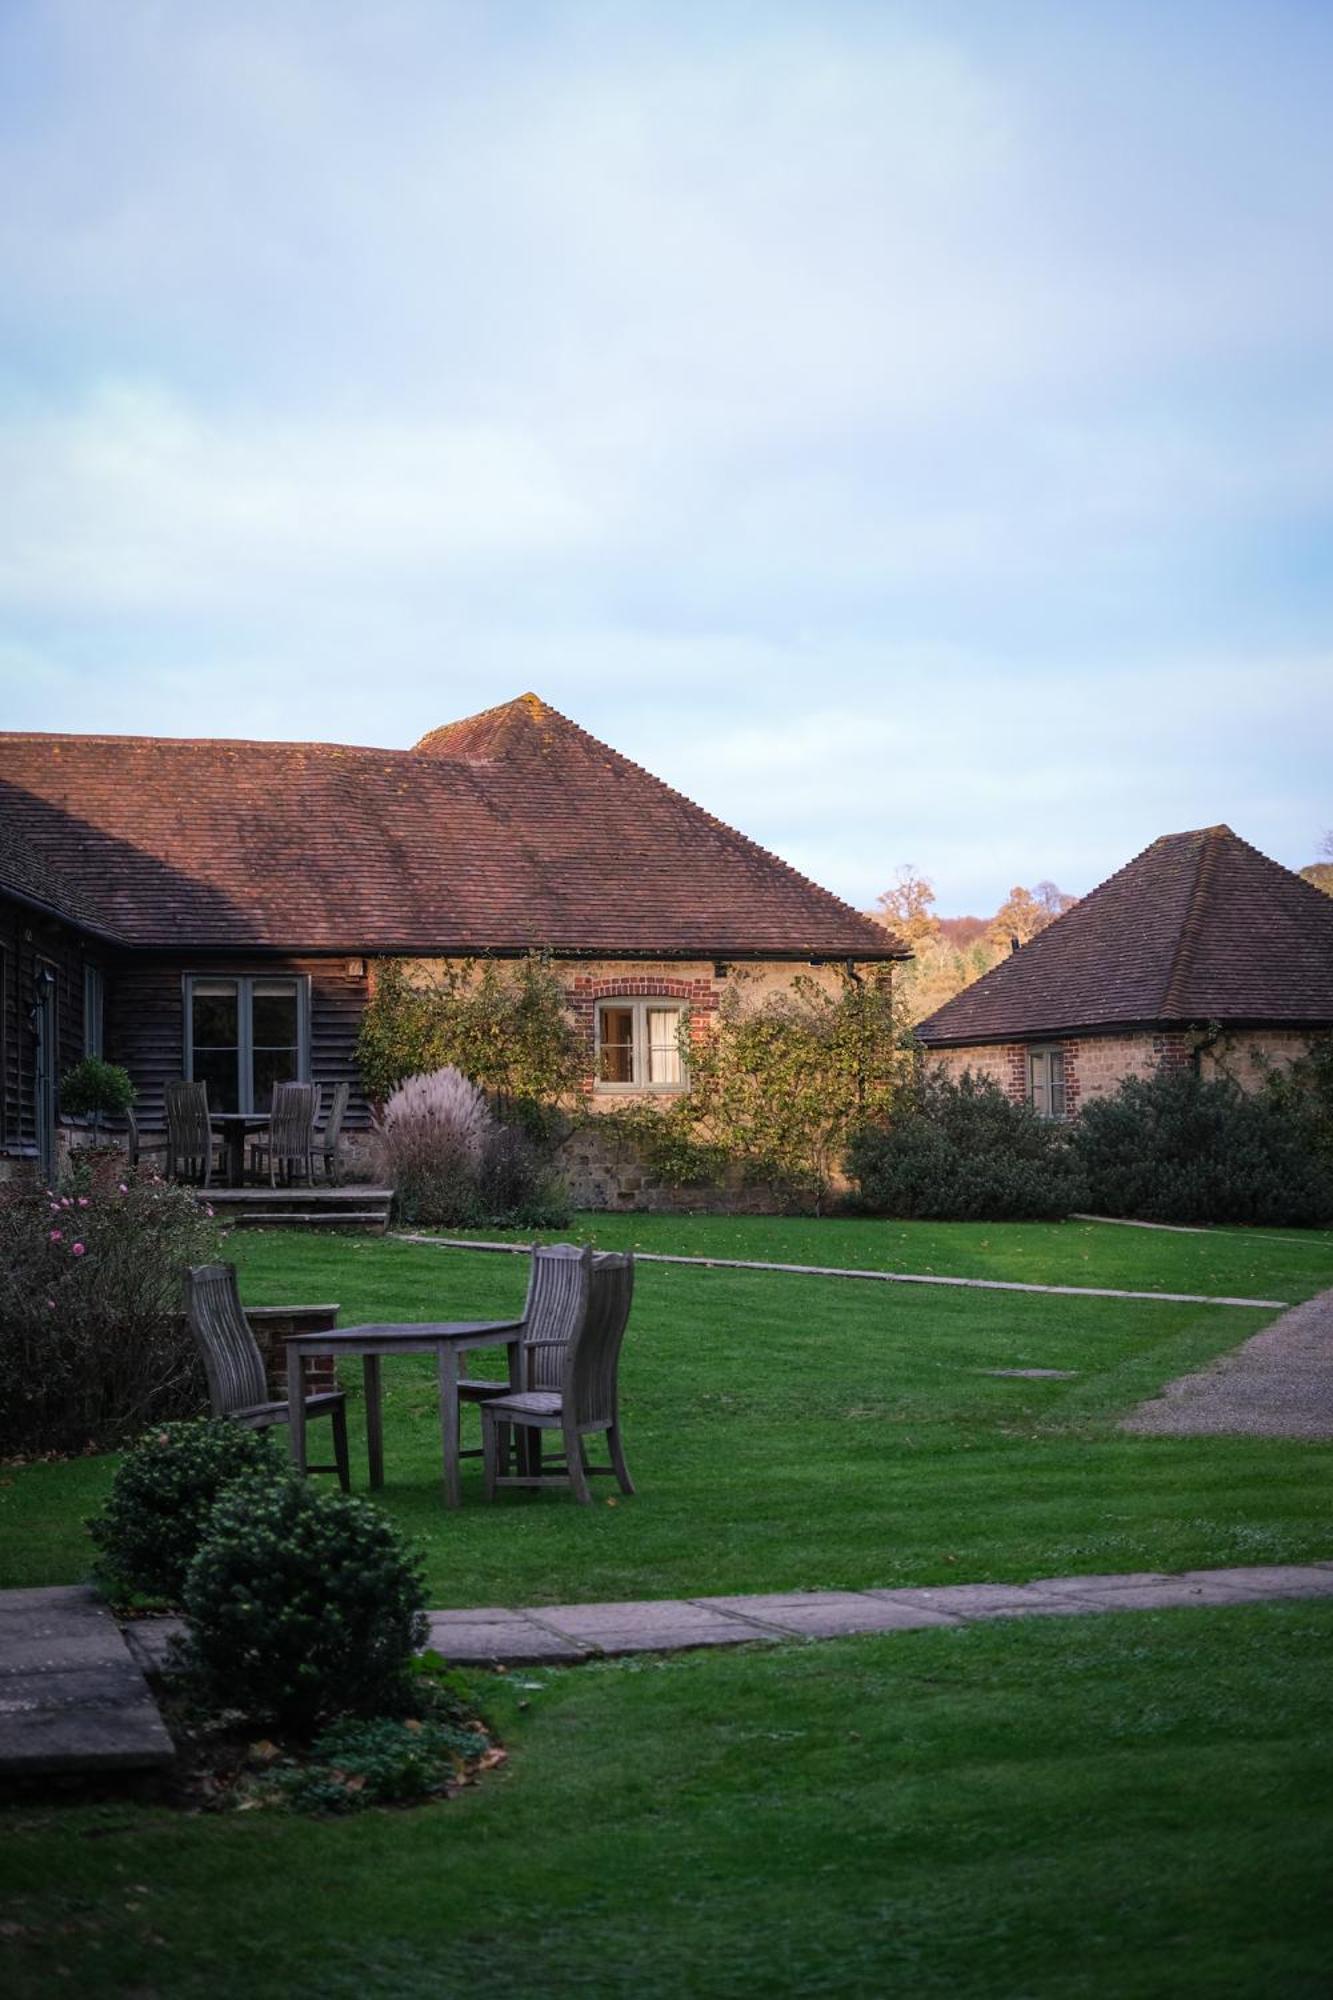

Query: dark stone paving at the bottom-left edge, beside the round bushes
[0,1586,174,1780]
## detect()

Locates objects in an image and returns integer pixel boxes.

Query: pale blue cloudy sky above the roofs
[0,0,1333,912]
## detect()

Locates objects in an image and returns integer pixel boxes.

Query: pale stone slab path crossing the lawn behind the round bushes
[116,1560,1333,1670]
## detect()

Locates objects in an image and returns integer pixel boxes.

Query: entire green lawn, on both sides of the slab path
[0,1216,1333,2000]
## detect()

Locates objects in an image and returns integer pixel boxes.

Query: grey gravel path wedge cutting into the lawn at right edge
[1121,1292,1333,1438]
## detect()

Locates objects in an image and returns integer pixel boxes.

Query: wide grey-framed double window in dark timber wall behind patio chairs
[184,972,310,1112]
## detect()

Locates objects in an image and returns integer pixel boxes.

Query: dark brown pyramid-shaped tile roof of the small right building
[917,826,1333,1048]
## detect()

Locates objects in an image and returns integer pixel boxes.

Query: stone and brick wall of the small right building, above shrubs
[931,1028,1311,1116]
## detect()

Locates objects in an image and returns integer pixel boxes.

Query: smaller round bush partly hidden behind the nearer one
[88,1416,284,1604]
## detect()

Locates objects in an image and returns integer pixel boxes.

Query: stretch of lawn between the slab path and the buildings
[0,1218,1333,1606]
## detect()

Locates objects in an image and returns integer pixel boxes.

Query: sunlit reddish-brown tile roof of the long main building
[0,694,907,960]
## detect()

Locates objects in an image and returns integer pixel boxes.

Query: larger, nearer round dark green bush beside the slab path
[182,1478,426,1736]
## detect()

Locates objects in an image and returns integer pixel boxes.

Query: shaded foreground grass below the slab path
[0,1602,1333,2000]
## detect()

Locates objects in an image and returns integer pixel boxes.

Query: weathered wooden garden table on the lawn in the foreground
[286,1320,522,1506]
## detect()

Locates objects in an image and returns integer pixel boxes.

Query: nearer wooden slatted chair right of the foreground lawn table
[480,1250,634,1504]
